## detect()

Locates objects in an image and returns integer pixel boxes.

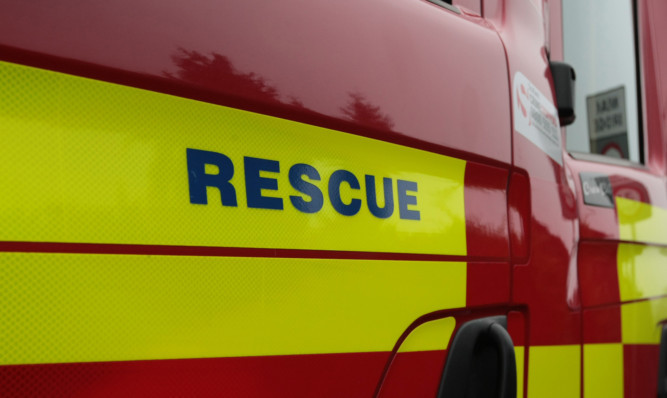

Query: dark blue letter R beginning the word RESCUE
[186,148,237,206]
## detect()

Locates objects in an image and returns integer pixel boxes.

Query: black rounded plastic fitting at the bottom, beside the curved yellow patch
[438,316,516,398]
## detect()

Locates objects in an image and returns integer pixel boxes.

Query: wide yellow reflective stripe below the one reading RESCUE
[0,253,466,364]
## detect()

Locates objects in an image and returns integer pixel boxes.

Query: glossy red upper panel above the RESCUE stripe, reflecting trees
[0,0,511,164]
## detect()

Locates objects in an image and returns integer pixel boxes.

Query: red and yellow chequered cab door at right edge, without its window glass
[552,1,667,397]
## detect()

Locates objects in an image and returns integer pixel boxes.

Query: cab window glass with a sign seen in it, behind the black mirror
[563,0,642,163]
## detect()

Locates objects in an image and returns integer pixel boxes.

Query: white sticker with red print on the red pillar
[512,72,563,165]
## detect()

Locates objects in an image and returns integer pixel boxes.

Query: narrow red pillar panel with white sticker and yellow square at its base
[484,0,581,397]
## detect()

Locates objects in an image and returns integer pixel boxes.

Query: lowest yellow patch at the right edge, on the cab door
[621,298,667,344]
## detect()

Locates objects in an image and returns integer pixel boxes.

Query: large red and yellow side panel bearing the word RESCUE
[0,0,511,397]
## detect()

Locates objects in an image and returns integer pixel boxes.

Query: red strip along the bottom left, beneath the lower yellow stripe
[0,352,389,398]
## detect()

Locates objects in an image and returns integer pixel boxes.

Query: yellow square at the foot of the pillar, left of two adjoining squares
[528,345,581,398]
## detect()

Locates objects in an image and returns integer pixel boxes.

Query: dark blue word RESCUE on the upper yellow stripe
[186,148,421,221]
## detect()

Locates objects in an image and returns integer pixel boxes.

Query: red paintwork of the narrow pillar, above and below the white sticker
[484,0,581,345]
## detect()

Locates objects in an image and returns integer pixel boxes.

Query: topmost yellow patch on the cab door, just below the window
[616,196,667,245]
